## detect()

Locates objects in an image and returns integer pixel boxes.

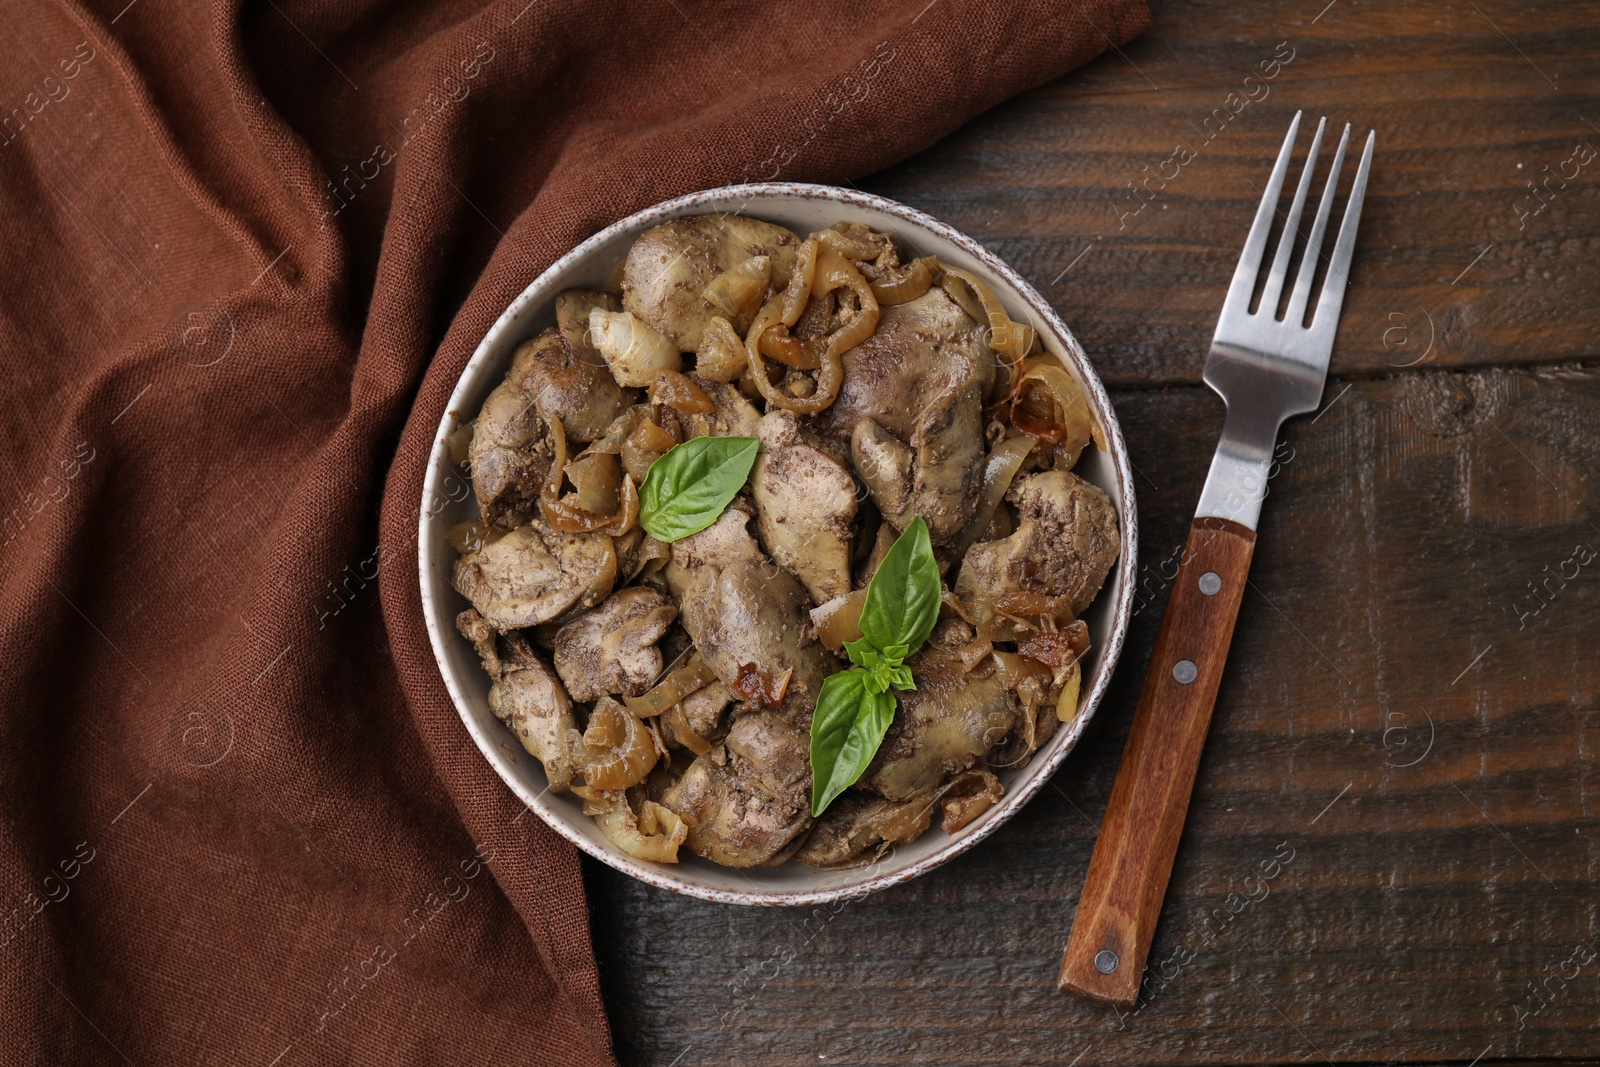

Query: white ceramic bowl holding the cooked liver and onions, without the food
[418,182,1138,905]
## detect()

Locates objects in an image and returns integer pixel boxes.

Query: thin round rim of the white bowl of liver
[418,181,1139,907]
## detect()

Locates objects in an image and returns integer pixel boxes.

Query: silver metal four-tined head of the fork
[1205,112,1376,425]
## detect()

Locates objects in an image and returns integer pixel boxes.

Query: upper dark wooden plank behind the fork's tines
[864,0,1600,384]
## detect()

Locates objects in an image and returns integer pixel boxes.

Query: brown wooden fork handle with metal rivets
[1058,518,1256,1006]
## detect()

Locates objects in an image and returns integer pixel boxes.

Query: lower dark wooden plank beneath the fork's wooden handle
[589,368,1600,1067]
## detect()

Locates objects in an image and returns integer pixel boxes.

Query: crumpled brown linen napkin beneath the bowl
[0,0,1147,1067]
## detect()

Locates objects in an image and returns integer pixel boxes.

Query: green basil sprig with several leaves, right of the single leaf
[811,517,941,817]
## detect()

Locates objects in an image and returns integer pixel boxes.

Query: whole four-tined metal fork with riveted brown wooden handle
[1058,112,1376,1006]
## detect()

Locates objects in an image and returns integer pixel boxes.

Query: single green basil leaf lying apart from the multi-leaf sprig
[638,437,762,542]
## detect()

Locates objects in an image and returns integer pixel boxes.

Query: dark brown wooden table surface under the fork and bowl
[587,0,1600,1067]
